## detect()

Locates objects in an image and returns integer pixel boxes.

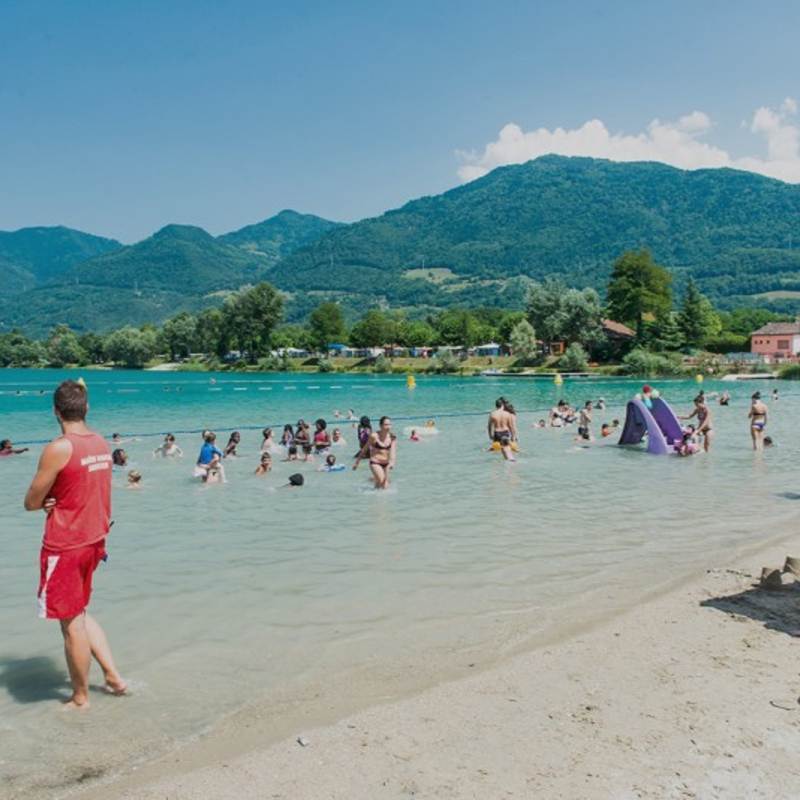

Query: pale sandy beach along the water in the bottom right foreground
[67,540,800,800]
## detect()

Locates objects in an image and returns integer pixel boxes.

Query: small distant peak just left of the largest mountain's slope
[217,210,343,266]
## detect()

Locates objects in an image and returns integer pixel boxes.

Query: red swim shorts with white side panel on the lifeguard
[39,539,106,619]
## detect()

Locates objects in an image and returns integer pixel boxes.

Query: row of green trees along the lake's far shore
[0,250,780,369]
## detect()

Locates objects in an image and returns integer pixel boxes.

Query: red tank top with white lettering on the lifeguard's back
[43,432,112,552]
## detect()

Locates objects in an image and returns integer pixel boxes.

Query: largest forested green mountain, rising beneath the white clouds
[270,156,800,305]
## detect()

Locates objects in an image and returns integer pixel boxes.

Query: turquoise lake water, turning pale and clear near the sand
[0,370,800,795]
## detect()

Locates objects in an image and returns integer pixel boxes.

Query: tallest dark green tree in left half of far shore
[222,281,283,361]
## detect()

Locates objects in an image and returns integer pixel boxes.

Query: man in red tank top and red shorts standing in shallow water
[25,381,128,708]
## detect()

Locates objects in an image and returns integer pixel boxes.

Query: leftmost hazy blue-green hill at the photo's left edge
[0,227,122,297]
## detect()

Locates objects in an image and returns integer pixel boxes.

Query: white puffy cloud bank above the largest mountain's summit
[457,98,800,183]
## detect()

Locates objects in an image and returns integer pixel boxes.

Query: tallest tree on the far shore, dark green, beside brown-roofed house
[606,250,672,338]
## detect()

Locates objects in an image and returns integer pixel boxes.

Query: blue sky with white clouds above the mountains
[0,0,800,244]
